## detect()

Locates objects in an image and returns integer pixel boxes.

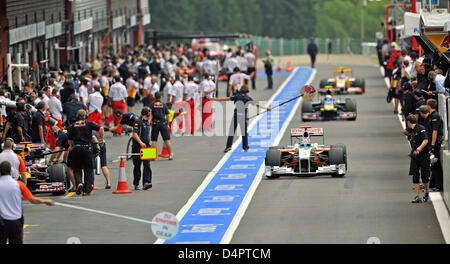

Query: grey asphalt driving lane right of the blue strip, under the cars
[231,65,445,244]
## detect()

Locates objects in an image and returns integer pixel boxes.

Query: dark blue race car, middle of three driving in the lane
[302,92,357,121]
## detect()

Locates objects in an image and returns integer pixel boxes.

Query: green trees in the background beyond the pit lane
[149,0,391,39]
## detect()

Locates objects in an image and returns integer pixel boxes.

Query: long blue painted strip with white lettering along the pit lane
[164,68,313,244]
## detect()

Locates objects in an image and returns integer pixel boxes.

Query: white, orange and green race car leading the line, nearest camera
[265,126,347,178]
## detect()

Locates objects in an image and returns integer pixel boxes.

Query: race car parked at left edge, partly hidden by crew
[14,142,70,194]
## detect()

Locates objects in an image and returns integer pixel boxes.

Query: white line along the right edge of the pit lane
[380,67,450,244]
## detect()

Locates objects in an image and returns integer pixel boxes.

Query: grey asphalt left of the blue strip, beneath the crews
[24,72,287,244]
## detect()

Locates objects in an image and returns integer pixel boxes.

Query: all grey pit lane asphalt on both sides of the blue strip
[24,65,444,244]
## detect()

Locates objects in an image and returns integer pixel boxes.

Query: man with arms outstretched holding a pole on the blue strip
[211,85,272,152]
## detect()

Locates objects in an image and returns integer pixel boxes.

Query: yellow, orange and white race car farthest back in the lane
[319,67,366,94]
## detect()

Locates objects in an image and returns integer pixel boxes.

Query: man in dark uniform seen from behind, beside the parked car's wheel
[67,110,104,195]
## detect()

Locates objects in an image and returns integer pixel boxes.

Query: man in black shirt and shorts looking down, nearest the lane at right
[405,114,430,203]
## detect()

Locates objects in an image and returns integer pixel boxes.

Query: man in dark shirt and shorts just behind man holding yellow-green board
[150,92,173,160]
